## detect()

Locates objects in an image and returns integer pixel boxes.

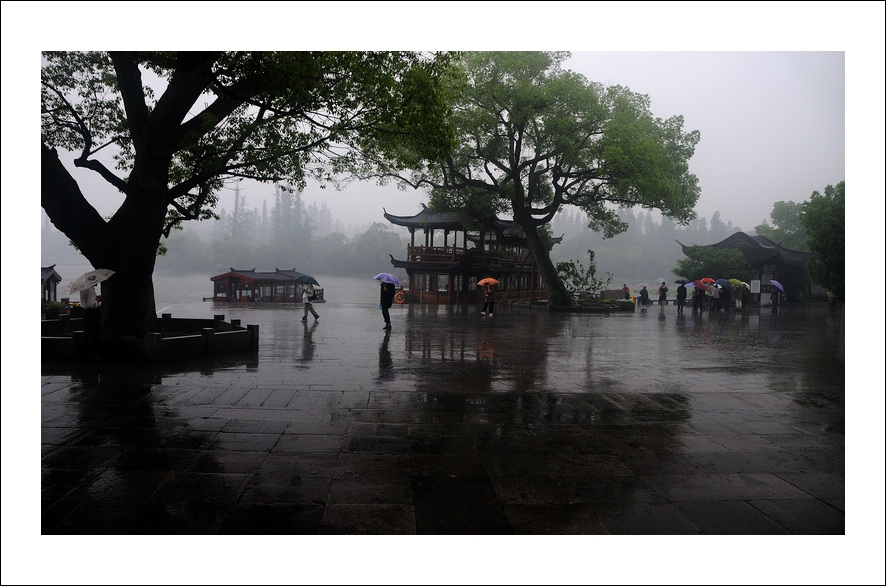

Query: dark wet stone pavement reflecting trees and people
[40,304,846,535]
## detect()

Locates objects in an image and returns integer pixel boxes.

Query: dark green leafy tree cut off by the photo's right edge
[800,181,846,299]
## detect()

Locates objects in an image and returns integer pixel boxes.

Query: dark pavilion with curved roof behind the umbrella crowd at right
[677,232,815,295]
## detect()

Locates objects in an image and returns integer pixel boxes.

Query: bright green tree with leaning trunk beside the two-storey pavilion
[364,52,699,305]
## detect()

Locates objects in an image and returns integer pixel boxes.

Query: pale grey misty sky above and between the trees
[36,51,846,230]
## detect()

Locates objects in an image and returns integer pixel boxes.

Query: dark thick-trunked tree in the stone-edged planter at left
[41,52,453,336]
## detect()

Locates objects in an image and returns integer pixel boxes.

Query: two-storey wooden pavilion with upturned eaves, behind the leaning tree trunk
[384,204,562,305]
